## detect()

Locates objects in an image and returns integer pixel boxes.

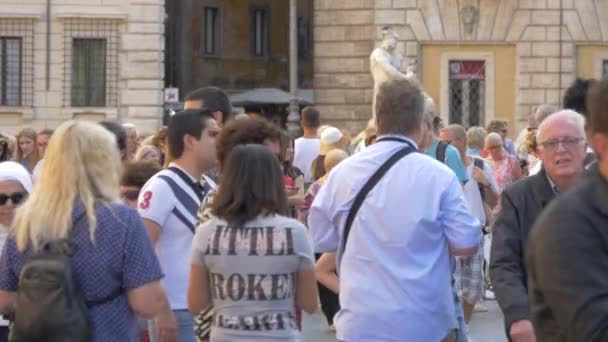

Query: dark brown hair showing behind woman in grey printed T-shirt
[215,117,281,170]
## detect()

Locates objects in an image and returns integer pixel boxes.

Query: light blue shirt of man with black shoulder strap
[308,137,481,342]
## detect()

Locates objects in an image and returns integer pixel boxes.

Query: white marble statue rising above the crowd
[369,27,416,118]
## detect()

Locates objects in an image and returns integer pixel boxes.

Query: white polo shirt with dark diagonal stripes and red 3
[137,163,213,310]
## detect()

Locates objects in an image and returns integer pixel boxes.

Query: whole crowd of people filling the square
[0,75,608,342]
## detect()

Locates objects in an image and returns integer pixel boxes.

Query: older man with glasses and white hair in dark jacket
[490,110,586,342]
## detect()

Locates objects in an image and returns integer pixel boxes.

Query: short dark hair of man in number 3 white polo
[167,110,213,159]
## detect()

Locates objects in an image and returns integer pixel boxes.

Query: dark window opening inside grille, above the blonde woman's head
[72,38,106,107]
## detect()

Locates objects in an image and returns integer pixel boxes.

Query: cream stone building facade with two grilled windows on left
[0,0,165,132]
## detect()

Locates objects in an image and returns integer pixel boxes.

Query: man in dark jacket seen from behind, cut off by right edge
[527,79,608,342]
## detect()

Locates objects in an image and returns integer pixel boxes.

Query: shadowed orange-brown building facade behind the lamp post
[165,0,313,96]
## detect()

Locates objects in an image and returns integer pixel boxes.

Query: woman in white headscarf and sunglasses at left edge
[0,161,32,342]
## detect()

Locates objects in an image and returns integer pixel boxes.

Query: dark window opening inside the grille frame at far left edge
[0,37,21,106]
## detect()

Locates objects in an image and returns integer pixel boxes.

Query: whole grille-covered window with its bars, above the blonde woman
[64,18,121,107]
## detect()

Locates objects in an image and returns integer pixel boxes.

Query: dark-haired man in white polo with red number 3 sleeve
[138,110,219,342]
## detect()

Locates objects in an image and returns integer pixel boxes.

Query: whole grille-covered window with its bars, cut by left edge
[0,18,34,107]
